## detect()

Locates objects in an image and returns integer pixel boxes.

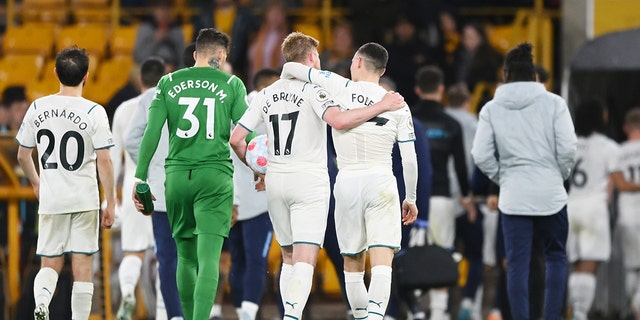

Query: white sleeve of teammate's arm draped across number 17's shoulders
[281,62,351,94]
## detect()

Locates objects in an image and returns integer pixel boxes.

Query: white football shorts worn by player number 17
[265,170,330,247]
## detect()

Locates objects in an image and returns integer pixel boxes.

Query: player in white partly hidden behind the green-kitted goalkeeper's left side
[111,57,165,319]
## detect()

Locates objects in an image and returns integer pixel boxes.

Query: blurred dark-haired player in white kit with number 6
[567,99,640,320]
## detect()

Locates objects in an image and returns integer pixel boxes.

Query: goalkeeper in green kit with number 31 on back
[133,28,247,320]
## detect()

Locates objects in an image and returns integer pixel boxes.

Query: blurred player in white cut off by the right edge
[616,107,640,318]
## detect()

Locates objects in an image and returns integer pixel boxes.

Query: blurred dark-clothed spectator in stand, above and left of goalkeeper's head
[133,0,185,72]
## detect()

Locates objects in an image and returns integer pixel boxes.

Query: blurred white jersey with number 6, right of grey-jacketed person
[569,133,620,199]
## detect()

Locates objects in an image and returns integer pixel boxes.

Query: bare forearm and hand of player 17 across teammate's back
[323,91,406,130]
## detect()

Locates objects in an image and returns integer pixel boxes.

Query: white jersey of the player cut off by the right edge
[618,141,640,225]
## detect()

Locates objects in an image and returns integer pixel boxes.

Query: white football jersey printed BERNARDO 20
[16,95,113,214]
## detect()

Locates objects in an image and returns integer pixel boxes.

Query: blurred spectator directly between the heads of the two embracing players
[320,20,356,78]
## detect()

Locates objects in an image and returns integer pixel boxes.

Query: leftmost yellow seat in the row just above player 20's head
[2,24,54,56]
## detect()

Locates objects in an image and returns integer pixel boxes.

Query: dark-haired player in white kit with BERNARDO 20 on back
[16,46,116,320]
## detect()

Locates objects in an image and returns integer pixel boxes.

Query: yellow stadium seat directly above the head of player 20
[56,24,108,59]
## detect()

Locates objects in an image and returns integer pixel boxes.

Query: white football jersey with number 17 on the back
[238,79,337,172]
